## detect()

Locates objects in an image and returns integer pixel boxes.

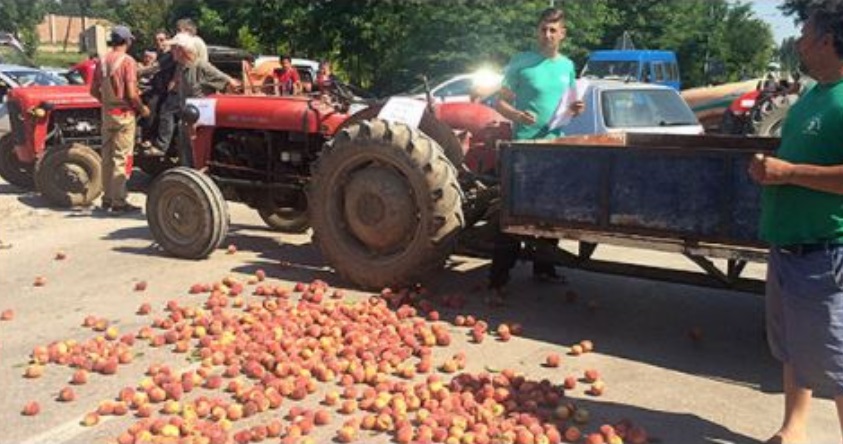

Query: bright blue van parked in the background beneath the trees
[580,49,682,91]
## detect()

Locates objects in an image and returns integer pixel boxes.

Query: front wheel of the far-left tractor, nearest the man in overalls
[35,143,103,207]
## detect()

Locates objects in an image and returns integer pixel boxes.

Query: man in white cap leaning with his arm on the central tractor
[169,33,240,166]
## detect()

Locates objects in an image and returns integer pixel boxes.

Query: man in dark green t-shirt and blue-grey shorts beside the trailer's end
[749,4,843,443]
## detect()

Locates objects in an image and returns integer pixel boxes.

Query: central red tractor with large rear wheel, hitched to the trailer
[146,84,510,288]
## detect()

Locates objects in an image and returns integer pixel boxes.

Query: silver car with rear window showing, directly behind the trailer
[562,80,704,136]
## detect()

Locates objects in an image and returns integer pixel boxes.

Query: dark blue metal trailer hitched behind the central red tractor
[499,133,778,292]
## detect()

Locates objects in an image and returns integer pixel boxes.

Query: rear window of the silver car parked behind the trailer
[601,88,699,128]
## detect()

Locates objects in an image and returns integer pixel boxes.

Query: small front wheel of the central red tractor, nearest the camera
[146,167,229,259]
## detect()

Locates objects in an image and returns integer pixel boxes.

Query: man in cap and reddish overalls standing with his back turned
[91,26,149,214]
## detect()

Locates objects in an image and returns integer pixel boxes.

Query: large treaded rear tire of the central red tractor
[307,120,464,289]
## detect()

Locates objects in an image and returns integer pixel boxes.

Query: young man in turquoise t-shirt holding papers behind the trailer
[489,8,585,297]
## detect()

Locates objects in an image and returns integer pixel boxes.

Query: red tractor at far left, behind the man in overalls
[0,77,175,206]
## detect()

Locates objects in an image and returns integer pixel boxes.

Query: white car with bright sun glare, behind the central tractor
[406,70,503,103]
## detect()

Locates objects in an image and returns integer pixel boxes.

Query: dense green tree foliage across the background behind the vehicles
[23,0,784,93]
